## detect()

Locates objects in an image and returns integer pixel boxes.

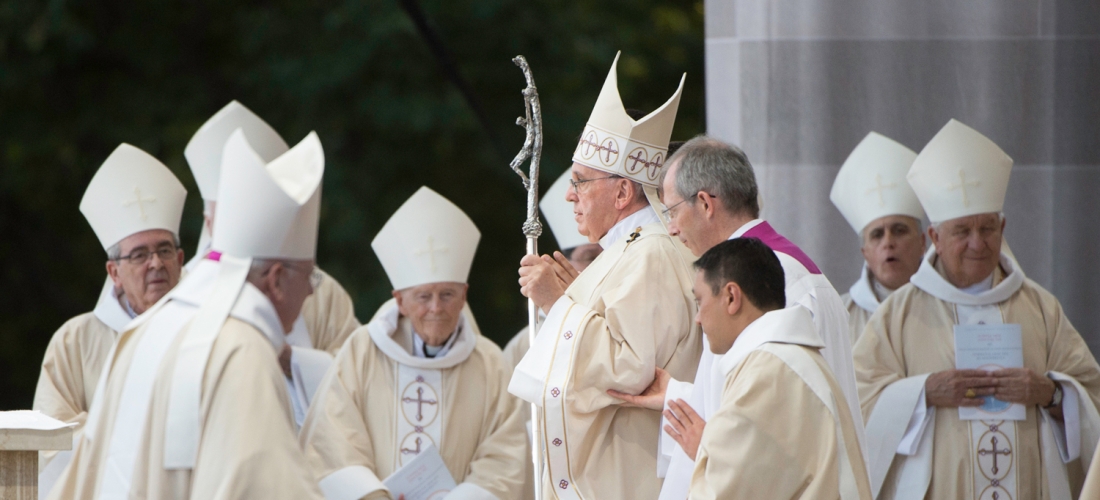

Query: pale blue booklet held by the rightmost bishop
[955,324,1027,420]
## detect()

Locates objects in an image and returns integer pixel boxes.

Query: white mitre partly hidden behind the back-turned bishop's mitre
[184,101,289,201]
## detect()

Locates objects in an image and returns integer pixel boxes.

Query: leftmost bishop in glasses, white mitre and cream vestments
[34,144,187,492]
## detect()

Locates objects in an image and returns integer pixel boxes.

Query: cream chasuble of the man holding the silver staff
[508,216,702,500]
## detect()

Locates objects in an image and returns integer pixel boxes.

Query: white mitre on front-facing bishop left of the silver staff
[371,187,481,290]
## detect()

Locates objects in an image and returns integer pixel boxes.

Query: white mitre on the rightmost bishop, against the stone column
[906,120,1012,223]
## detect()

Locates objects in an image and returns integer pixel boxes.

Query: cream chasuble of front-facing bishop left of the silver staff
[299,300,528,500]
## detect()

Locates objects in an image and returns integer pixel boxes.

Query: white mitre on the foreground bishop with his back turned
[211,130,325,260]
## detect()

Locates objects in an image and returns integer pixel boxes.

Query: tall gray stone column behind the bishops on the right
[706,0,1100,353]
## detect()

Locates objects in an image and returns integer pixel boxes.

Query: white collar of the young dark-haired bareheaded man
[718,305,825,375]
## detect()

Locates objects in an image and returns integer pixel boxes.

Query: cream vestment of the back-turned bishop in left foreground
[50,262,320,500]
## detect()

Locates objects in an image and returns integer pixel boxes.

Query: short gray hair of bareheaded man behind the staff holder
[660,134,760,219]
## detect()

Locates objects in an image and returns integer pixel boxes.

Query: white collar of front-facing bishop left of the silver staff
[366,299,477,369]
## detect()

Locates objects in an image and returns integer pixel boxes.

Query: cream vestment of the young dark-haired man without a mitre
[691,308,871,500]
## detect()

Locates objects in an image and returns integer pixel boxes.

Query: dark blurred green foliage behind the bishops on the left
[0,0,705,410]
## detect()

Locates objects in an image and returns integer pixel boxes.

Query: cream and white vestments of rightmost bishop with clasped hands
[854,247,1100,500]
